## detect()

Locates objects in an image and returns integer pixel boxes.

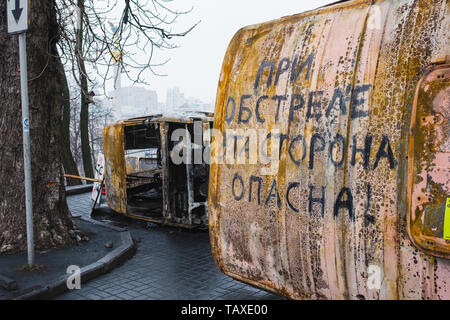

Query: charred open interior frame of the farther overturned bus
[124,115,212,227]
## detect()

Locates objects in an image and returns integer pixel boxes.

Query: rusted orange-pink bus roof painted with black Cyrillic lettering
[209,0,450,299]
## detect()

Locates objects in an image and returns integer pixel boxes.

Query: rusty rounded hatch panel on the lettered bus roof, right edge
[408,65,450,259]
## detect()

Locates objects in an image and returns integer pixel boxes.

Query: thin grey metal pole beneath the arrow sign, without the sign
[19,33,34,266]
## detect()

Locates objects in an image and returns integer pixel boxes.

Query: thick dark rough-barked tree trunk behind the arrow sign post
[0,0,77,253]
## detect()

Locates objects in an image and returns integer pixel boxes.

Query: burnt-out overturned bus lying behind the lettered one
[103,112,213,228]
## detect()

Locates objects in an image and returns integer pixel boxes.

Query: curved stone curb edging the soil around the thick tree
[12,230,136,300]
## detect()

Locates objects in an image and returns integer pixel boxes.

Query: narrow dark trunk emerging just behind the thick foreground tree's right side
[58,59,82,186]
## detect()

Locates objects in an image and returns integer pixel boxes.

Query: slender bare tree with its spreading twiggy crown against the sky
[58,0,195,177]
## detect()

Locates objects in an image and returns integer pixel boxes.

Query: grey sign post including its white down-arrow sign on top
[6,0,34,267]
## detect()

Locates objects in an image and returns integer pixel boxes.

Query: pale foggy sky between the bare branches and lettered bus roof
[110,0,335,105]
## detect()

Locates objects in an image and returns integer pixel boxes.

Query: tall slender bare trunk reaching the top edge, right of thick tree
[76,0,94,178]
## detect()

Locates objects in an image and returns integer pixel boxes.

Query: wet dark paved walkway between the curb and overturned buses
[57,193,283,300]
